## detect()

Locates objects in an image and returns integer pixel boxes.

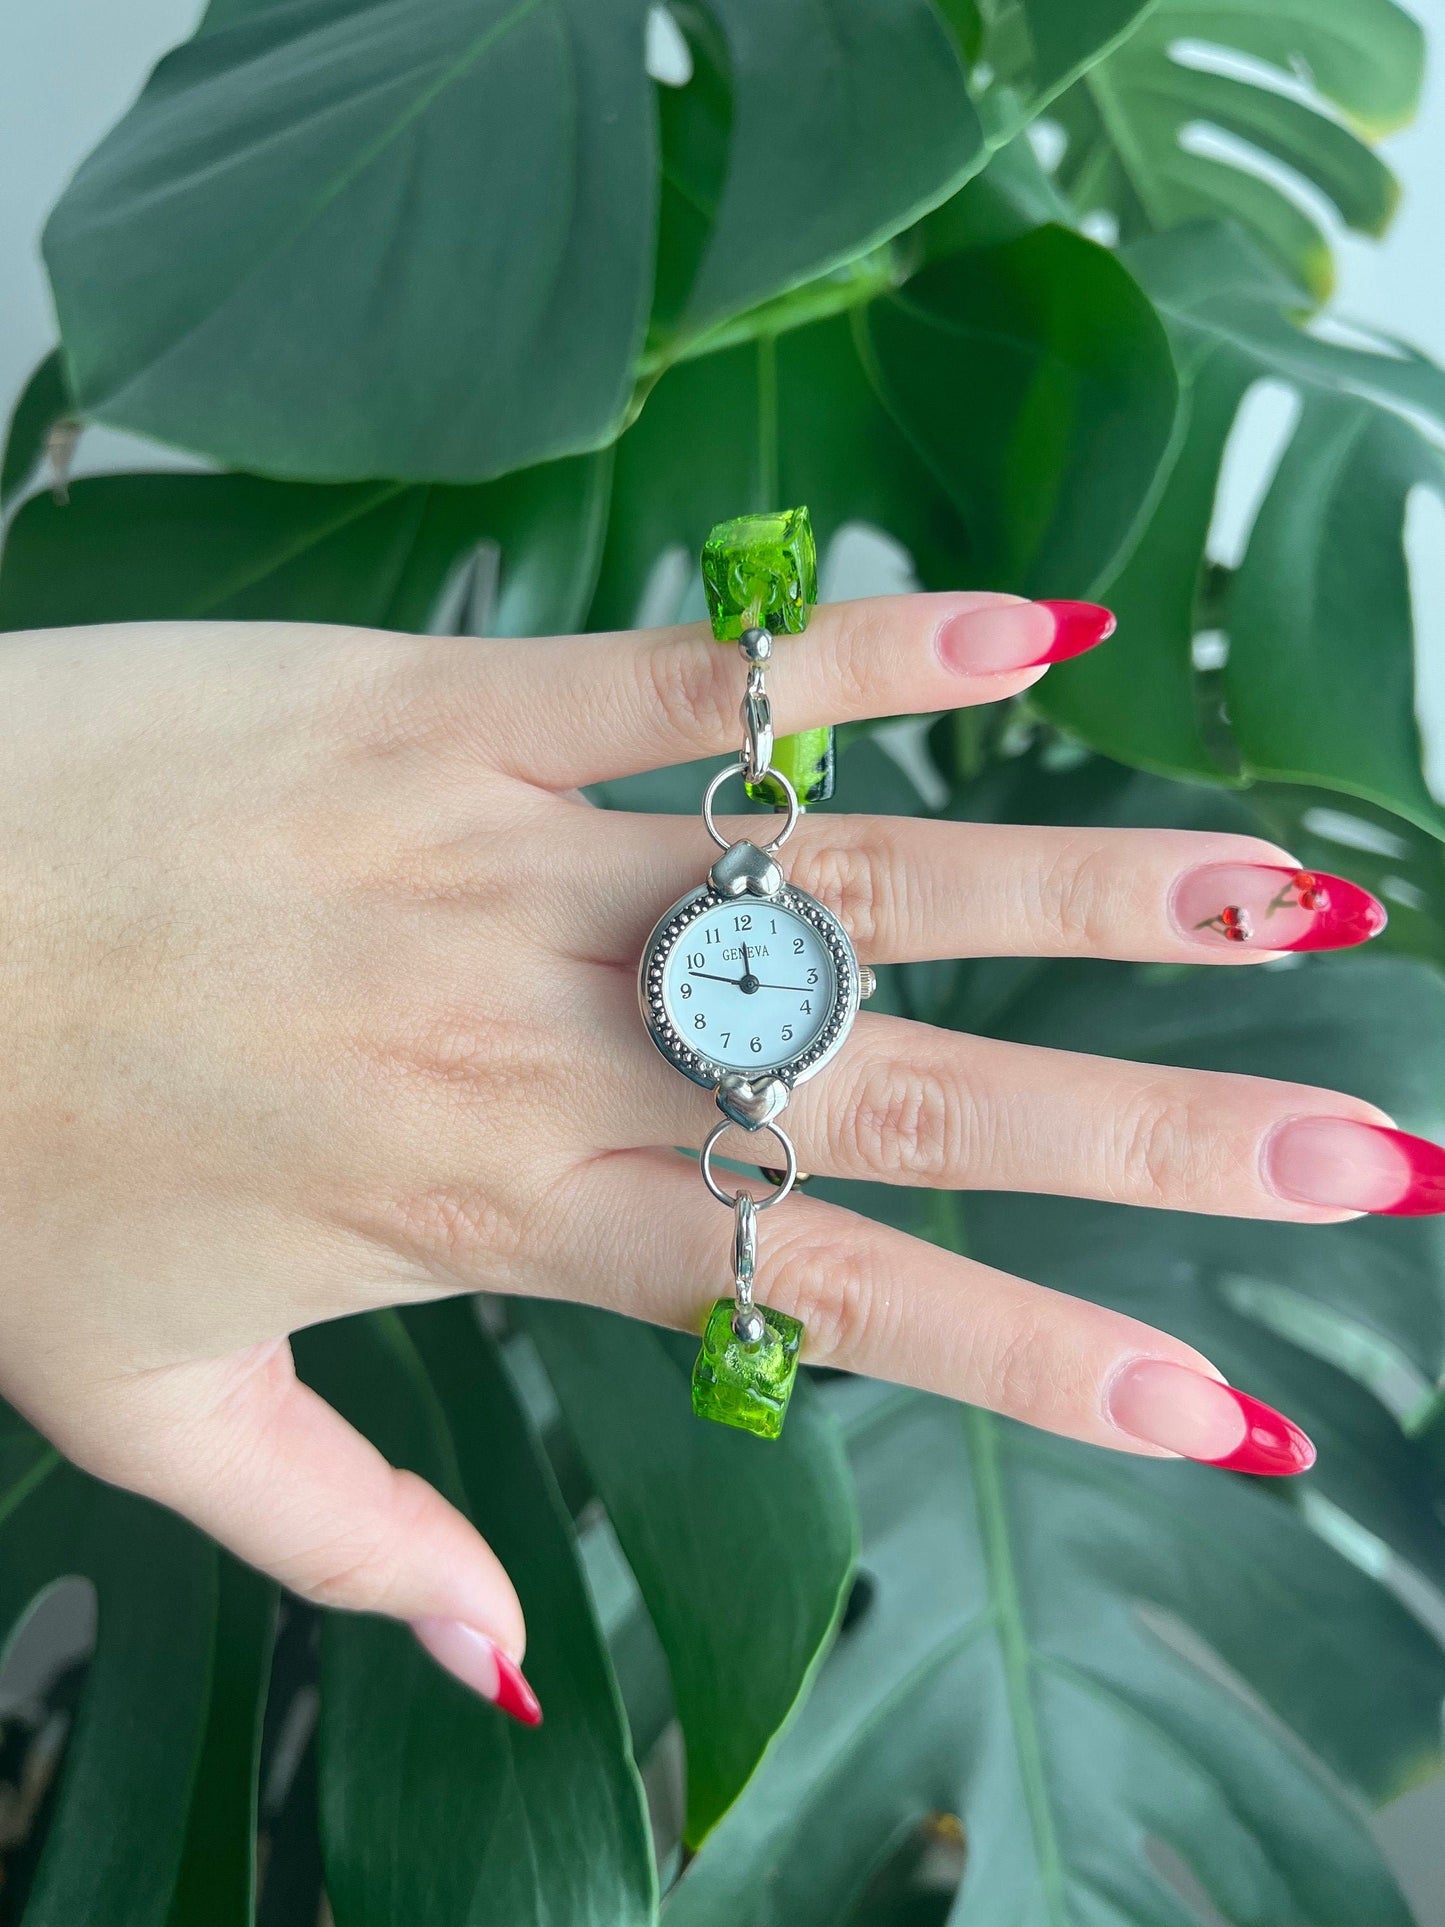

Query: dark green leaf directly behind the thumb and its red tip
[297,1301,655,1927]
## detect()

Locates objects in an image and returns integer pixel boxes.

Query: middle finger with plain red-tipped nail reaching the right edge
[576,969,1418,1224]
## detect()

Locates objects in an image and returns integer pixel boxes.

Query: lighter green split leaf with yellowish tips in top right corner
[1058,0,1424,299]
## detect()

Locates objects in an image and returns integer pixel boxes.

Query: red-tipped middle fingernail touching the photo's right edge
[1262,1118,1445,1218]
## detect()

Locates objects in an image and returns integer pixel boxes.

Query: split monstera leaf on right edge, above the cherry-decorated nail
[1042,216,1445,834]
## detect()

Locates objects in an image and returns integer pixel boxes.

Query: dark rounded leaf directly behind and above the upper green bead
[590,227,1177,628]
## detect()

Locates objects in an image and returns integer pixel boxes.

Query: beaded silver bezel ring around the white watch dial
[638,883,859,1091]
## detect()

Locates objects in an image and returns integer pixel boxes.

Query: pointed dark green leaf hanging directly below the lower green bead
[528,1301,855,1846]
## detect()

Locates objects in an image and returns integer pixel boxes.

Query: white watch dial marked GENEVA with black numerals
[663,898,838,1071]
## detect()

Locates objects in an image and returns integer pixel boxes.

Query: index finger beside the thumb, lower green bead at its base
[555,1150,1314,1474]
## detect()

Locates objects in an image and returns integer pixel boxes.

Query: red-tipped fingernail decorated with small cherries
[1169,863,1387,950]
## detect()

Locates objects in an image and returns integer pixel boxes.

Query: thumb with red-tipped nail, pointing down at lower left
[72,1339,541,1727]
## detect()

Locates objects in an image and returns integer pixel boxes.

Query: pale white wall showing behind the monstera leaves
[0,0,1445,1927]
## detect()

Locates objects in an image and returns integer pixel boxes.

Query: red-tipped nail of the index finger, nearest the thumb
[1106,1359,1314,1478]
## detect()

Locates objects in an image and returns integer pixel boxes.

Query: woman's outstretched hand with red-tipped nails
[0,595,1445,1717]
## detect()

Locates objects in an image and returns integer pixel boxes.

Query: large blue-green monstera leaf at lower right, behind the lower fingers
[665,763,1445,1927]
